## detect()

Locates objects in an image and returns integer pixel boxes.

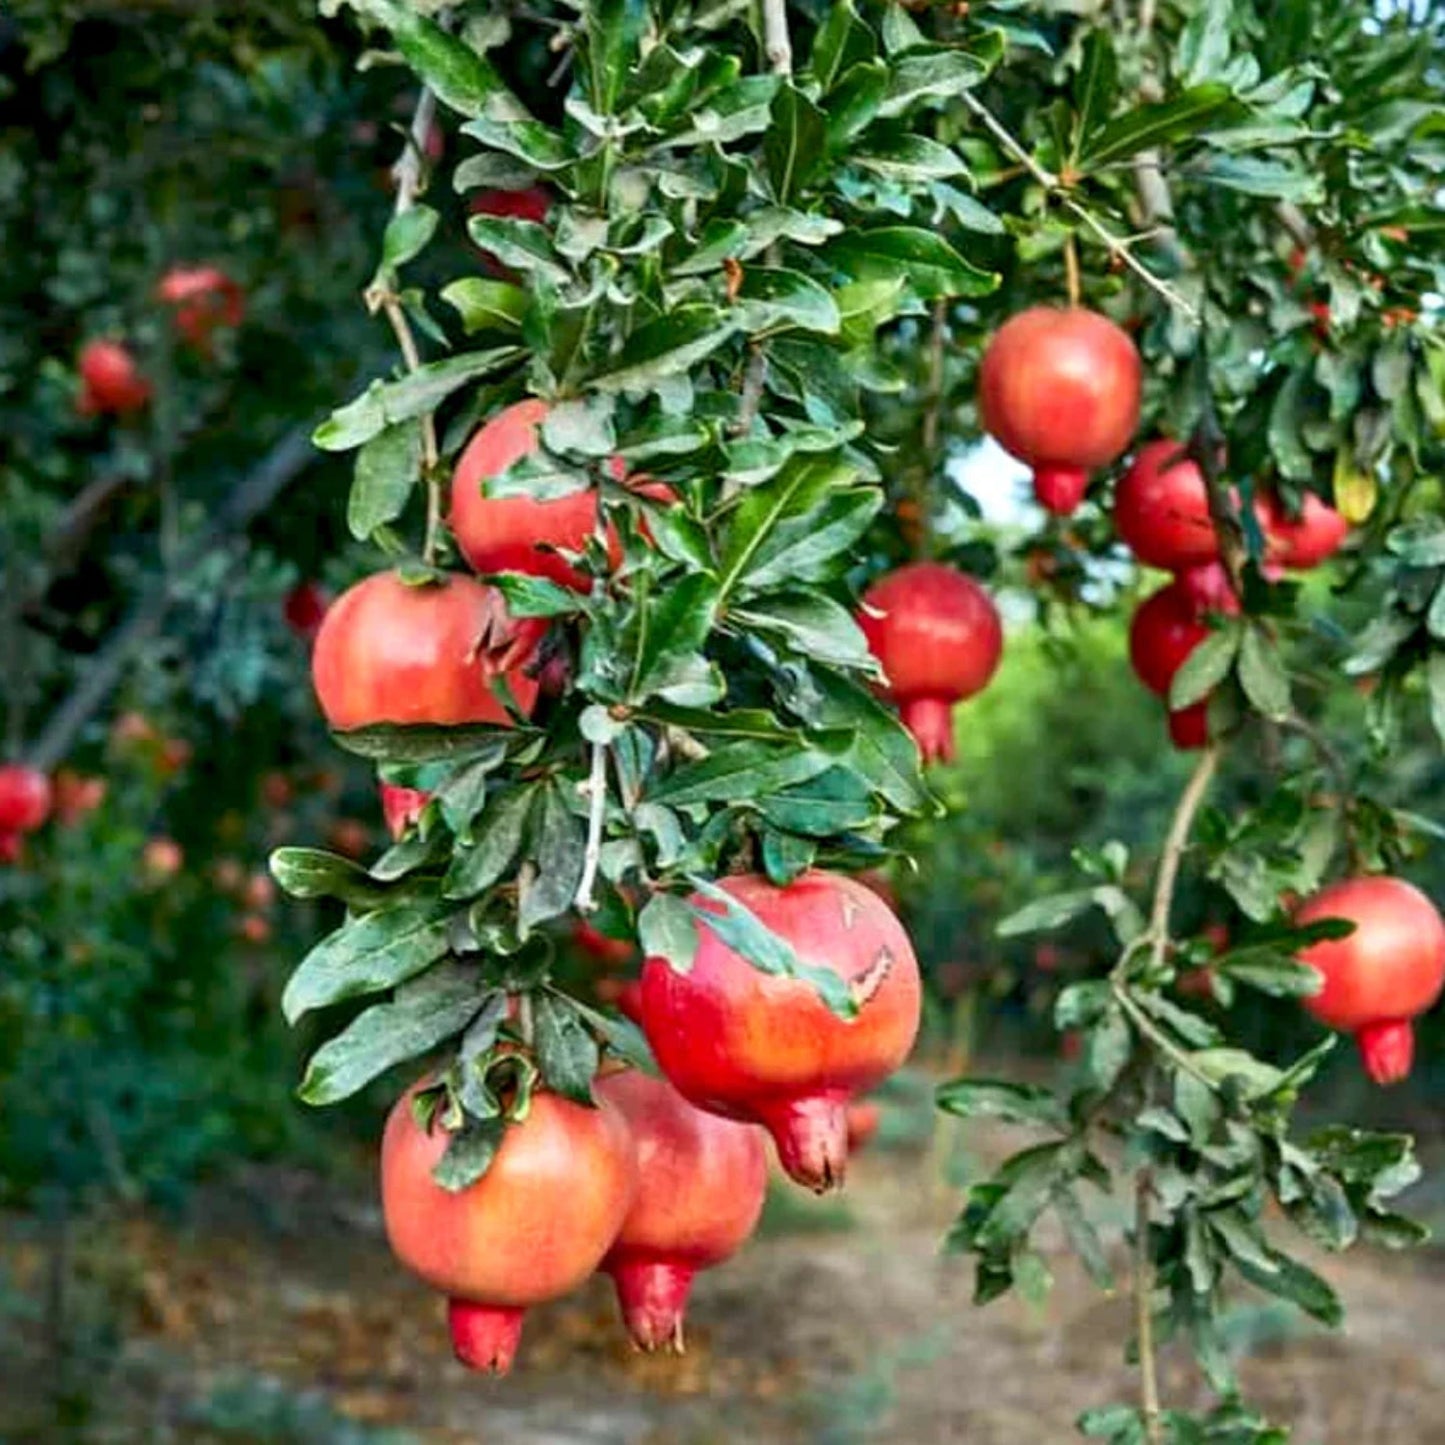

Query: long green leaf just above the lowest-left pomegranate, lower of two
[298,964,483,1105]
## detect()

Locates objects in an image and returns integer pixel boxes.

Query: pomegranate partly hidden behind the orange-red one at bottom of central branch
[595,1069,767,1353]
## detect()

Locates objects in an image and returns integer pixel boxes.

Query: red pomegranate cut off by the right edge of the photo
[1295,877,1445,1084]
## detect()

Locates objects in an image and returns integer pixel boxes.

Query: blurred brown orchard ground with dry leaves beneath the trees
[0,1061,1445,1445]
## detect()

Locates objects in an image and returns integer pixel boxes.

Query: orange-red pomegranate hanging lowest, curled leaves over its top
[381,1085,637,1374]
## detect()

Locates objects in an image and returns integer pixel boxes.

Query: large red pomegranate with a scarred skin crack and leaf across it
[642,871,920,1192]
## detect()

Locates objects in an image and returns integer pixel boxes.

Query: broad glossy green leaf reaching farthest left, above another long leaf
[280,900,449,1023]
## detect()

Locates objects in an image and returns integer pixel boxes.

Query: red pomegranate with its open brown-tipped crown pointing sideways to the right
[311,572,546,730]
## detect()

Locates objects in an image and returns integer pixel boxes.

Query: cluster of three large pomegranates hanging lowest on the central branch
[381,871,920,1373]
